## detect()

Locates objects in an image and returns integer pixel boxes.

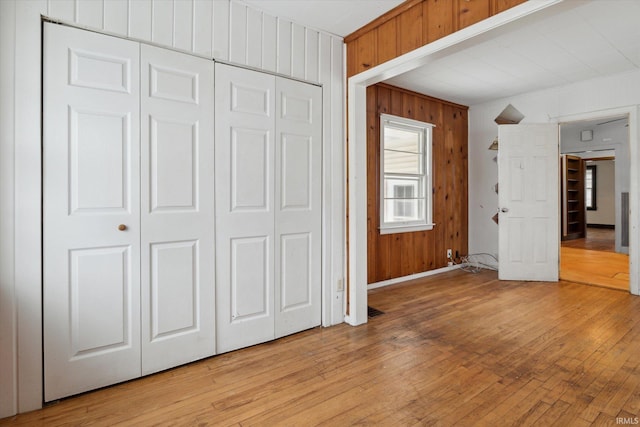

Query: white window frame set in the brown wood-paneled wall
[378,114,435,234]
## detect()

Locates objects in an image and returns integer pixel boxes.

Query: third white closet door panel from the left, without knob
[215,64,275,352]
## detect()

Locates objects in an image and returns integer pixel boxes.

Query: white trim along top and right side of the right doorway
[557,105,640,295]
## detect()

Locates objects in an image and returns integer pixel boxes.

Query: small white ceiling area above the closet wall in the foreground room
[244,0,404,37]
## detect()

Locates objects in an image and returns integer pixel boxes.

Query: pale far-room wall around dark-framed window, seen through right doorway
[587,160,616,225]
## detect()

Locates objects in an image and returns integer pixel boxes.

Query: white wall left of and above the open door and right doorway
[469,71,640,260]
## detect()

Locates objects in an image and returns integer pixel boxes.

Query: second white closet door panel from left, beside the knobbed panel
[140,45,215,374]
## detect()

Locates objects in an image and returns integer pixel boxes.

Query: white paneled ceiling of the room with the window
[388,0,640,105]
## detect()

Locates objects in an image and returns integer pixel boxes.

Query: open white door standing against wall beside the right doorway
[498,124,560,281]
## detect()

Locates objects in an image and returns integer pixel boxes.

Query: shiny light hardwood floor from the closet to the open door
[0,271,640,427]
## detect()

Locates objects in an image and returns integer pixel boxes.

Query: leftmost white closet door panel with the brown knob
[43,23,140,401]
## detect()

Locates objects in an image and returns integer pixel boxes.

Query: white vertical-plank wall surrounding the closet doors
[0,0,345,418]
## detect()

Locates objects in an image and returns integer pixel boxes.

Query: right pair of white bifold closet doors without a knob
[216,64,322,352]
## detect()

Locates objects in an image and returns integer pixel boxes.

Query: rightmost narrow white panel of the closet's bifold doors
[275,78,322,337]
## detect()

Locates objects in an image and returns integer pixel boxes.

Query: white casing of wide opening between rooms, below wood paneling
[345,0,564,325]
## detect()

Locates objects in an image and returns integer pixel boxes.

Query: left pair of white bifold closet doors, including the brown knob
[43,24,215,401]
